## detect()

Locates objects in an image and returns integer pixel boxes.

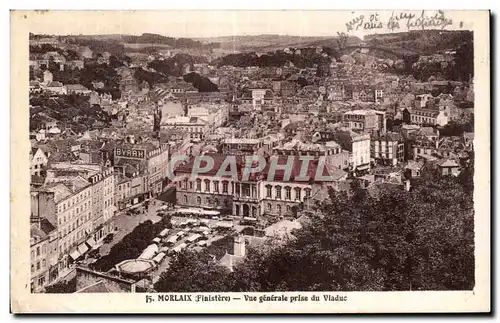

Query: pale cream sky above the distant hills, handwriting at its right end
[25,10,472,38]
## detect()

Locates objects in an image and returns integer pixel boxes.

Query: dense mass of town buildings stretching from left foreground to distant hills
[30,35,474,291]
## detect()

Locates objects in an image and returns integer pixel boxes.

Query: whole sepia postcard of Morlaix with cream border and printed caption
[10,10,491,313]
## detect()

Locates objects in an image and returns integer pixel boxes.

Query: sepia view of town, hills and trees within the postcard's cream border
[29,30,475,293]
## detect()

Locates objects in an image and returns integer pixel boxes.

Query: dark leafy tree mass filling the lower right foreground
[148,175,474,292]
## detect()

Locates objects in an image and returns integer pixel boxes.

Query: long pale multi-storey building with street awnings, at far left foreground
[31,163,116,282]
